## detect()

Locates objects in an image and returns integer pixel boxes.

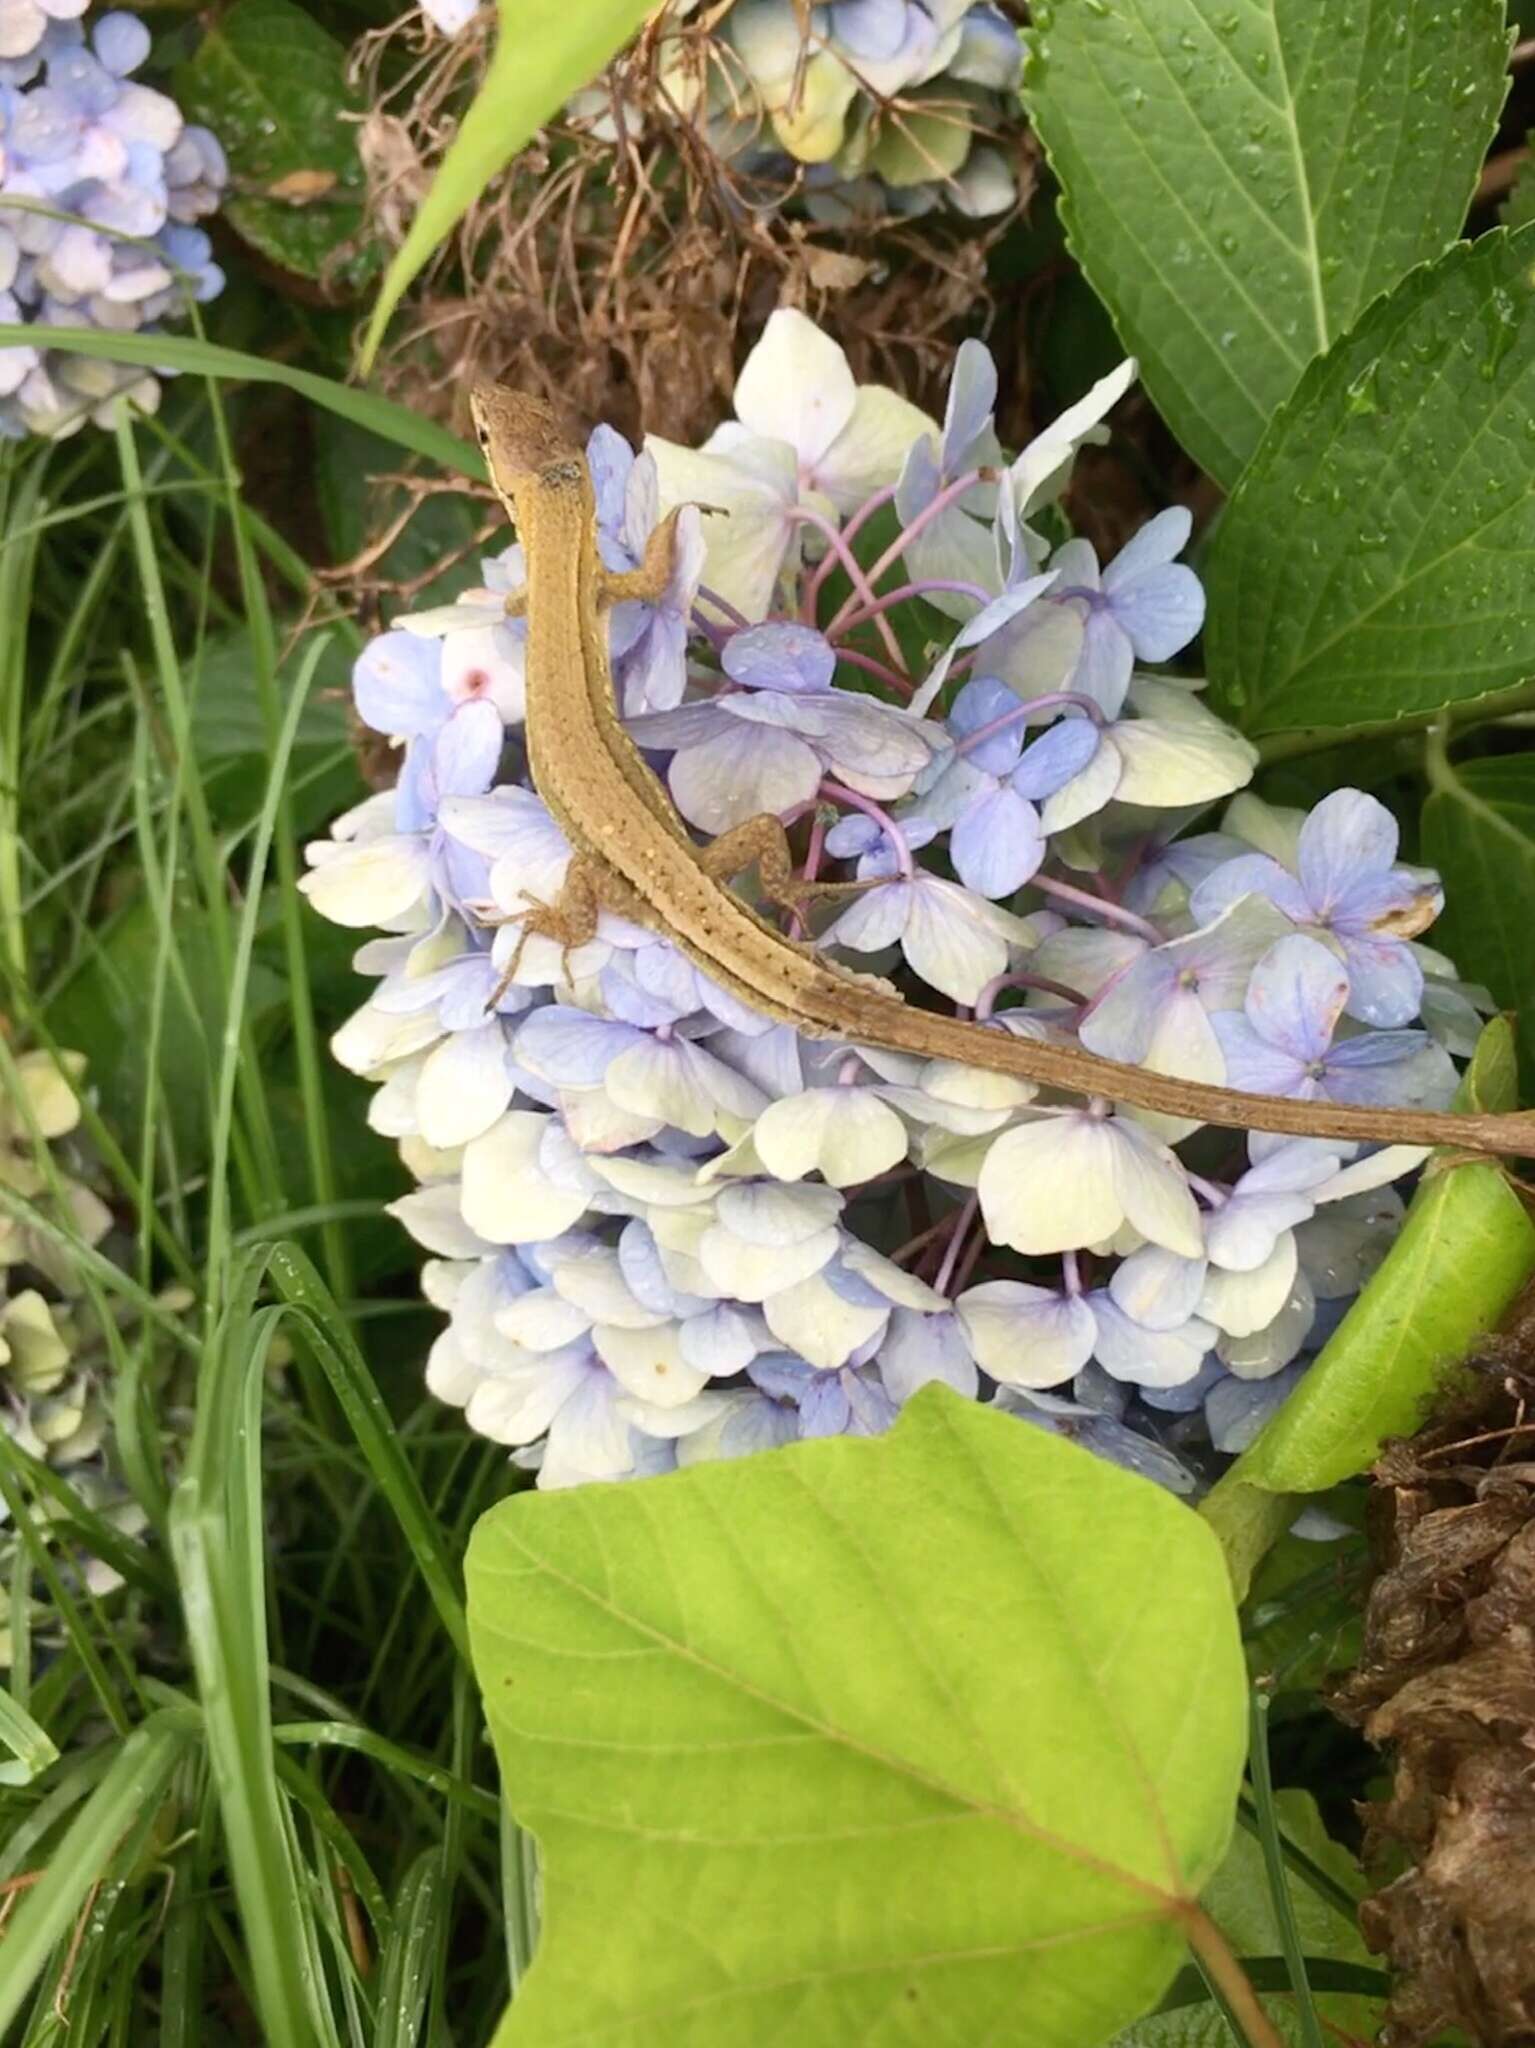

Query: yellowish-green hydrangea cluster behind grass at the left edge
[0,1053,184,1669]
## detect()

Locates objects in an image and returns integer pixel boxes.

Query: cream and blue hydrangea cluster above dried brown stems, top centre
[421,0,1023,223]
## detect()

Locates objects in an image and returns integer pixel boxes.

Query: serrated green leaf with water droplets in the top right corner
[1025,0,1508,487]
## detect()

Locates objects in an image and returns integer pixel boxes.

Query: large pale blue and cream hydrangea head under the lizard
[305,311,1476,1491]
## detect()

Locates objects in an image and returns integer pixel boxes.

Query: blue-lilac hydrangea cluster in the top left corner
[0,0,229,438]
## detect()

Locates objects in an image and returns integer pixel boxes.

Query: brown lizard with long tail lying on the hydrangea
[471,385,1535,1155]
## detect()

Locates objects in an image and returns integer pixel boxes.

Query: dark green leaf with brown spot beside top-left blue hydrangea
[176,0,377,283]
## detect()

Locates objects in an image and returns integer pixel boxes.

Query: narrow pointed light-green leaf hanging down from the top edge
[362,0,655,371]
